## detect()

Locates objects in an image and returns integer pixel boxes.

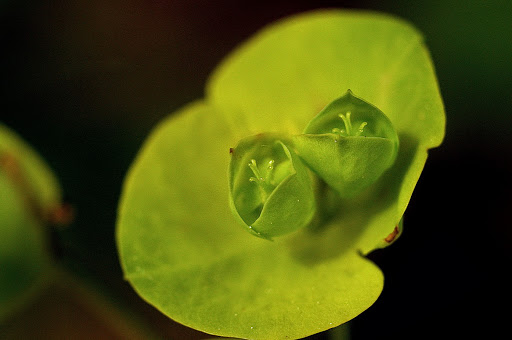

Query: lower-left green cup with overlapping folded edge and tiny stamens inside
[229,134,315,239]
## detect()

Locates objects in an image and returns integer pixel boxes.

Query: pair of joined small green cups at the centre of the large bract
[229,90,398,239]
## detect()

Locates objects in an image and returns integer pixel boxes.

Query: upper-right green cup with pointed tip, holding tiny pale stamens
[293,90,398,197]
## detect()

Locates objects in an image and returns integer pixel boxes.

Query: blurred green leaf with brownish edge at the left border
[0,124,61,321]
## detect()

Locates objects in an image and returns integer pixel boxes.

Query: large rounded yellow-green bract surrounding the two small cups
[117,11,444,339]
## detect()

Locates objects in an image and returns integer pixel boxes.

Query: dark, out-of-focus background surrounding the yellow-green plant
[0,0,512,339]
